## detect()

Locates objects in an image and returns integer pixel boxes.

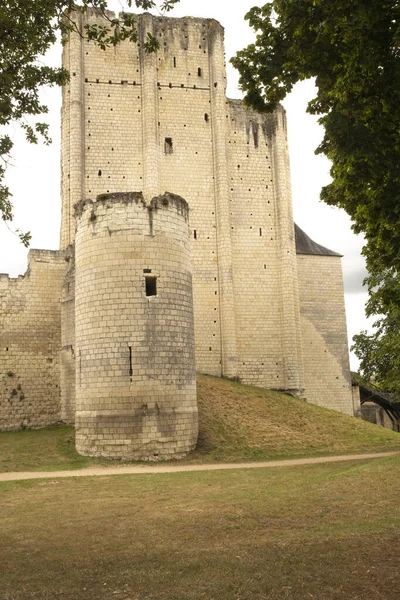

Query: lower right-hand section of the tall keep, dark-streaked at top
[228,100,302,392]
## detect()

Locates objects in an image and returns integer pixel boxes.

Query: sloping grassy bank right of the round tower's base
[189,375,400,461]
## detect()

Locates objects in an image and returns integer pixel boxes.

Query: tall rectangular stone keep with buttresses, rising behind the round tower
[61,10,304,393]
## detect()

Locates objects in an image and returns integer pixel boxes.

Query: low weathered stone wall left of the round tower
[0,250,66,431]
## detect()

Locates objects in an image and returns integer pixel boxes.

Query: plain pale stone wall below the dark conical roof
[297,254,353,415]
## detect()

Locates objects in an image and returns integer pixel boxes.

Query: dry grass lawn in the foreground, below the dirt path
[0,457,400,600]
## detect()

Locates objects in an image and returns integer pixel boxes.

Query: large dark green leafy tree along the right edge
[232,0,400,390]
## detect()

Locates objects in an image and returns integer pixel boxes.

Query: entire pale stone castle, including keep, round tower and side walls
[0,10,354,458]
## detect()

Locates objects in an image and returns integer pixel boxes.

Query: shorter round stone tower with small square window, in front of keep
[75,193,198,460]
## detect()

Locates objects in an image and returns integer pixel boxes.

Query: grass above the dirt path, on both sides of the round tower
[0,375,400,471]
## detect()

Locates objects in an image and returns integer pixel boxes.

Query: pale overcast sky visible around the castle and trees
[0,0,371,370]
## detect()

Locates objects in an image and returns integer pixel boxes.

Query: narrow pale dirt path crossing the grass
[0,452,400,481]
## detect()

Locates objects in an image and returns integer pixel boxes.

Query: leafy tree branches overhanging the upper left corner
[0,0,179,246]
